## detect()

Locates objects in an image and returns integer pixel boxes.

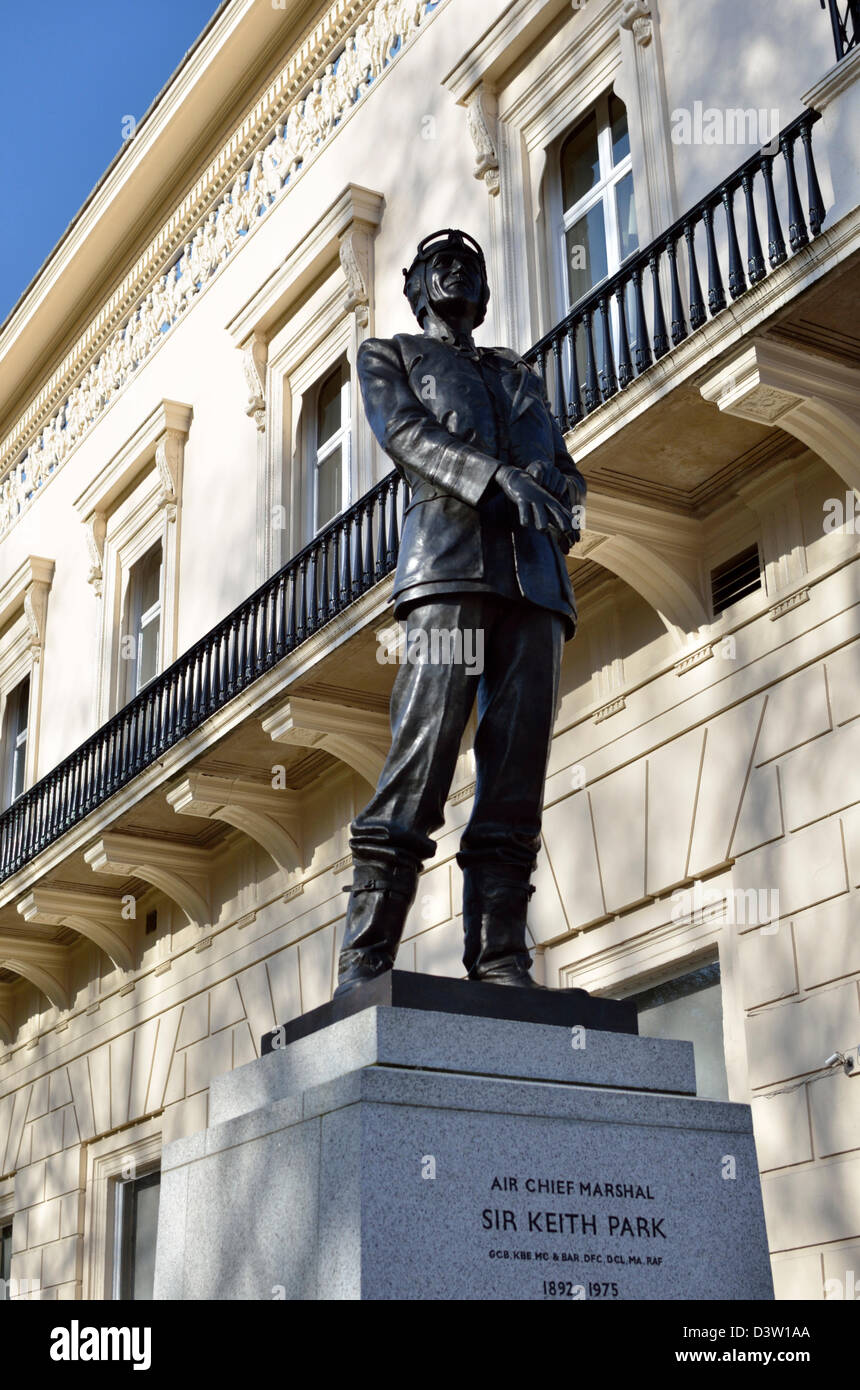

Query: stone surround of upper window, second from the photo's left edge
[75,400,193,726]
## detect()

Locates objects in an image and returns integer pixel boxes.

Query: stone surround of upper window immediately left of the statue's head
[226,183,383,582]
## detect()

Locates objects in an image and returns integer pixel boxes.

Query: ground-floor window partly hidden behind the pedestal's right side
[629,960,728,1101]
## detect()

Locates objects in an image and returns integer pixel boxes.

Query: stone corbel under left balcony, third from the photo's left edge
[83,834,210,927]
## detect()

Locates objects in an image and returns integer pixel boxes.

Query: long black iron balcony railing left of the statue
[0,473,407,880]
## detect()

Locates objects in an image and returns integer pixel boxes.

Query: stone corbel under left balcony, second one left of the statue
[167,773,301,873]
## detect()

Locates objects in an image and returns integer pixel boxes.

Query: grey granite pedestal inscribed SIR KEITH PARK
[156,981,772,1301]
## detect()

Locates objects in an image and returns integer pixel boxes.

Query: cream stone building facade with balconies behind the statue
[0,0,860,1300]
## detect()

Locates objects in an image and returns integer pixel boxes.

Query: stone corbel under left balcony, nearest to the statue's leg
[263,695,390,787]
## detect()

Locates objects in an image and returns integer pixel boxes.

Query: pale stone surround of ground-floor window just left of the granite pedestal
[82,1119,161,1300]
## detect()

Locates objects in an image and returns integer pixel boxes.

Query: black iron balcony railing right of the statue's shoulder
[525,111,825,430]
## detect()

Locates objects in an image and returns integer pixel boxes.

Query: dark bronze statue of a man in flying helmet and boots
[336,229,585,994]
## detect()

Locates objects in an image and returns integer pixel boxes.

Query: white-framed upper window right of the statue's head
[559,92,639,309]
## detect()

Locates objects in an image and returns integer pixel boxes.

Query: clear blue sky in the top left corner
[0,0,218,322]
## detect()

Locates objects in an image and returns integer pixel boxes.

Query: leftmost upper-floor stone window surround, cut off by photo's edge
[0,555,54,802]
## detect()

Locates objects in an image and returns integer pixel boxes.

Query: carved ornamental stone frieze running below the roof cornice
[0,0,439,537]
